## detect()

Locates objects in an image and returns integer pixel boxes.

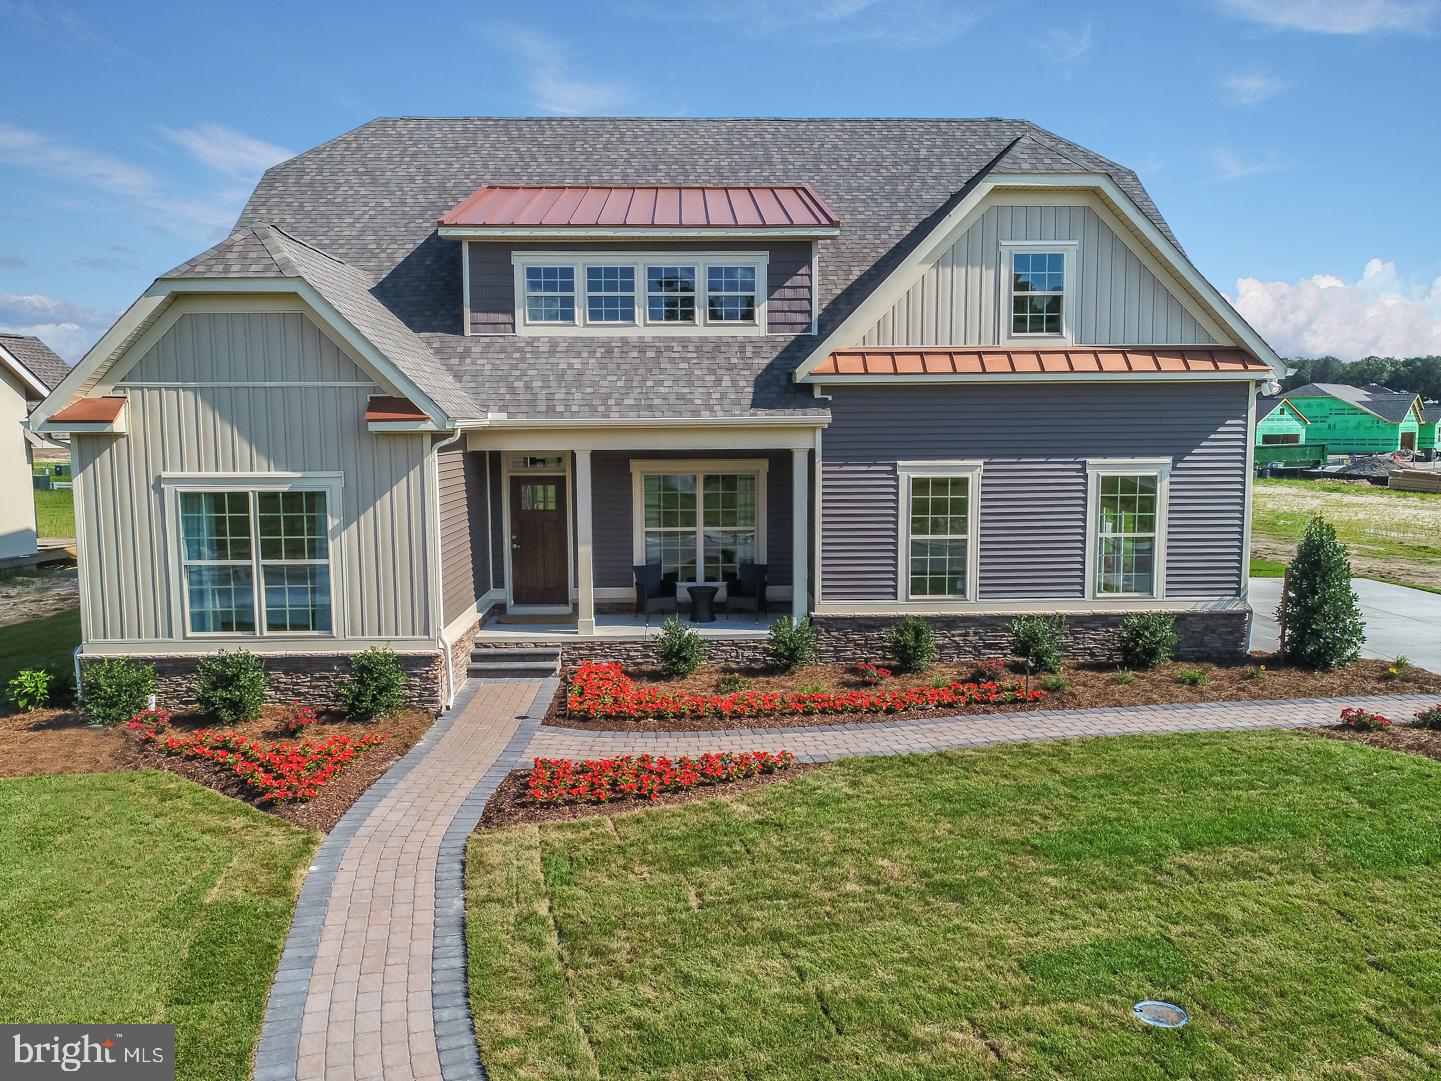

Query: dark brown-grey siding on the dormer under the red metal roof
[470,241,811,336]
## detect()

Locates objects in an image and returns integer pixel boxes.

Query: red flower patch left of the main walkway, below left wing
[130,718,391,803]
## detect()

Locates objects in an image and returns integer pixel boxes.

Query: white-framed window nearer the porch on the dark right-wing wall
[898,461,981,601]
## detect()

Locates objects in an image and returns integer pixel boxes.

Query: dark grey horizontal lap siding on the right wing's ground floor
[821,382,1246,604]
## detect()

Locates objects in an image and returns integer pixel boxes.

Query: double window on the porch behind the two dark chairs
[631,461,765,582]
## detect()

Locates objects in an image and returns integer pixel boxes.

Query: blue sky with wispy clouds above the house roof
[0,0,1441,359]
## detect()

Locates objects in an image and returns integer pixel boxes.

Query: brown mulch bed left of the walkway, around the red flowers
[0,706,435,830]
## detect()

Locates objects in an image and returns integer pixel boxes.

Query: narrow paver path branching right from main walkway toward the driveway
[529,695,1435,761]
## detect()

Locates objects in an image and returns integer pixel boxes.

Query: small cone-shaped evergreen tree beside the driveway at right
[1277,515,1366,670]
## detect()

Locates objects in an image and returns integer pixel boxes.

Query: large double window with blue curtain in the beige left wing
[179,489,331,634]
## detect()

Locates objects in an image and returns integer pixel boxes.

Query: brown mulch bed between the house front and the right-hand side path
[545,654,1441,732]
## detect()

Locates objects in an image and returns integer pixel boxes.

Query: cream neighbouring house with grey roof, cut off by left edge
[0,333,69,559]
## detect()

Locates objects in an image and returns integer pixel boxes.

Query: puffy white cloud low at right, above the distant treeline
[1233,259,1441,360]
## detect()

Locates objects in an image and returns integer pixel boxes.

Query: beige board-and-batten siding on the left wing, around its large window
[73,313,434,646]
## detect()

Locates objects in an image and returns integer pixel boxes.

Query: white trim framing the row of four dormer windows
[510,251,769,337]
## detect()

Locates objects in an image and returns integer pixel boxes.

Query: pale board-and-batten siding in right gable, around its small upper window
[860,205,1215,347]
